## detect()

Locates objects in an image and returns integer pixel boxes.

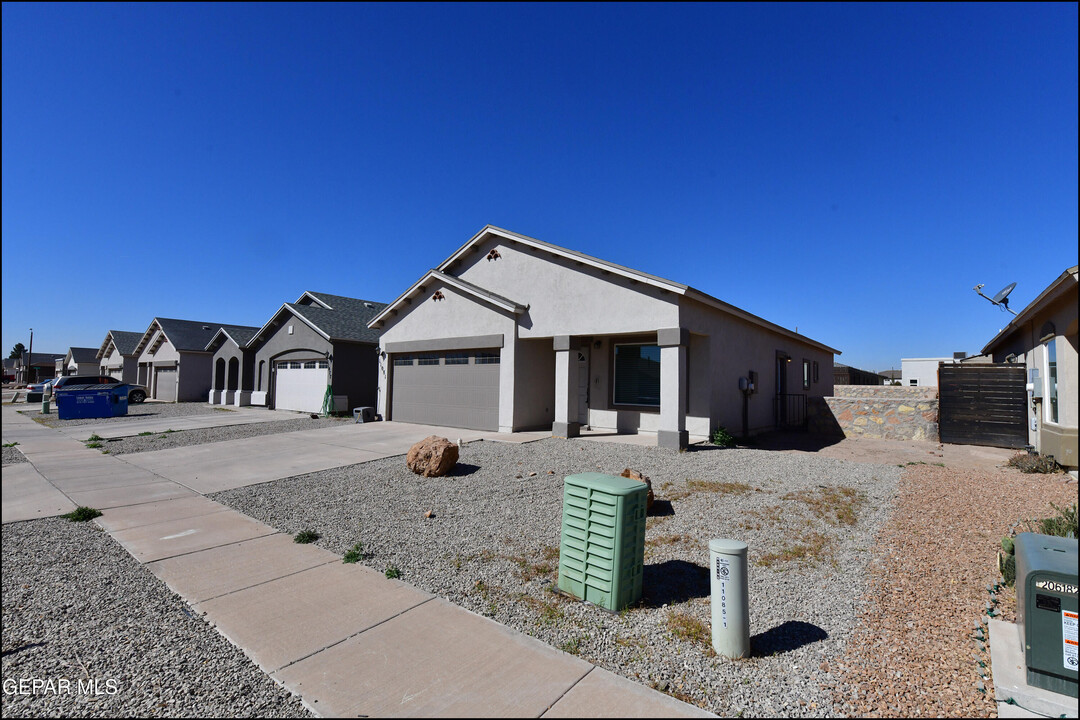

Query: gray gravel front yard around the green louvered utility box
[213,439,900,717]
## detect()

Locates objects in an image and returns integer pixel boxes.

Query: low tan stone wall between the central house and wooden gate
[807,385,940,443]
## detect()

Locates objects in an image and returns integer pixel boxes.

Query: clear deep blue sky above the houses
[2,2,1078,370]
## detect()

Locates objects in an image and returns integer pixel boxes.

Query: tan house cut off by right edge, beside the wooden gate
[983,266,1080,473]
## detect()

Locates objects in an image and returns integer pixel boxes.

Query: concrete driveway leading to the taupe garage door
[119,422,551,493]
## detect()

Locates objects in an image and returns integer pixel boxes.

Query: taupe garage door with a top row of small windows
[390,348,499,431]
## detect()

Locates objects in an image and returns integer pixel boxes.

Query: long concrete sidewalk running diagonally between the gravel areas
[3,407,712,717]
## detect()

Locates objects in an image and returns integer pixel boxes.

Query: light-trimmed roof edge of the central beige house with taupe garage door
[368,225,840,355]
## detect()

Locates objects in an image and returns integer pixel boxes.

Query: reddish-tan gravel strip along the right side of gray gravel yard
[834,459,1077,717]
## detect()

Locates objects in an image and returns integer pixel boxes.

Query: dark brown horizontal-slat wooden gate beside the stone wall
[937,363,1028,448]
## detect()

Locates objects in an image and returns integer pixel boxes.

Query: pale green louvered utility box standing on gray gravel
[558,473,649,612]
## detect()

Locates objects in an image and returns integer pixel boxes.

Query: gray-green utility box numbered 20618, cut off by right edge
[1015,532,1077,697]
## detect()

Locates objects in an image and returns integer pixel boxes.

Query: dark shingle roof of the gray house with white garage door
[248,291,387,345]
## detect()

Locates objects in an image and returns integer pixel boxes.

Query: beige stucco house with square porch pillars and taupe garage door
[369,226,838,447]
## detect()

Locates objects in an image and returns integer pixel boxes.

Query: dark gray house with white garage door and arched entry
[248,293,386,412]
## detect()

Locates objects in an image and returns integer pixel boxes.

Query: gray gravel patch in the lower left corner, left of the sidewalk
[2,518,311,718]
